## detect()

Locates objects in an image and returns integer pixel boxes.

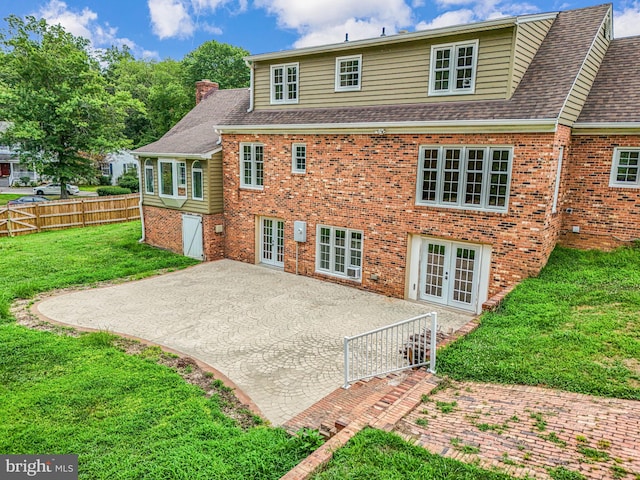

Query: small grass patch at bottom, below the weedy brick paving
[312,429,511,480]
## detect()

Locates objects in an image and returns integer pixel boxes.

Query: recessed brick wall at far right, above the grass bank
[560,135,640,249]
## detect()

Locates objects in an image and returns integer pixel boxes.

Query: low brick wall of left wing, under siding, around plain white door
[142,205,224,260]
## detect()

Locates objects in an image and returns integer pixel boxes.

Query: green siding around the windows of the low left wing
[141,152,223,214]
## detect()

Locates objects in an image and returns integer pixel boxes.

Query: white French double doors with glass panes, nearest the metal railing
[418,240,482,310]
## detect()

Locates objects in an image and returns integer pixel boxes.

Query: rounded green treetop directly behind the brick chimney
[182,40,250,89]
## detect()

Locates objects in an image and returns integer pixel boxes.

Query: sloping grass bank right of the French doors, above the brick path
[438,247,640,400]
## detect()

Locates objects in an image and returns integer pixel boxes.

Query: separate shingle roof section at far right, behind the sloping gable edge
[578,36,640,123]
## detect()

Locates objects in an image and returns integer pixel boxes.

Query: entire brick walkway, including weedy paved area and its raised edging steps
[283,376,640,480]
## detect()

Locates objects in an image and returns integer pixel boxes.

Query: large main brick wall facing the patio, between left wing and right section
[223,128,569,297]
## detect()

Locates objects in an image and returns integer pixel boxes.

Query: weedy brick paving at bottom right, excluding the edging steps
[400,382,640,479]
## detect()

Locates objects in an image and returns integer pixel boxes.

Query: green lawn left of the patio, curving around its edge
[0,222,308,480]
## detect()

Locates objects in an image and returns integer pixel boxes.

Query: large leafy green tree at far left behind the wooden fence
[0,15,139,198]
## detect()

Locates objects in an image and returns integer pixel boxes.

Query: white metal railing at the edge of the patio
[343,312,438,388]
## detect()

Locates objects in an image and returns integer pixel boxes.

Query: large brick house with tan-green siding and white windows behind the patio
[134,4,640,312]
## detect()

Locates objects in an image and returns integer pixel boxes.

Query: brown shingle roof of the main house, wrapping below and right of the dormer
[218,4,611,130]
